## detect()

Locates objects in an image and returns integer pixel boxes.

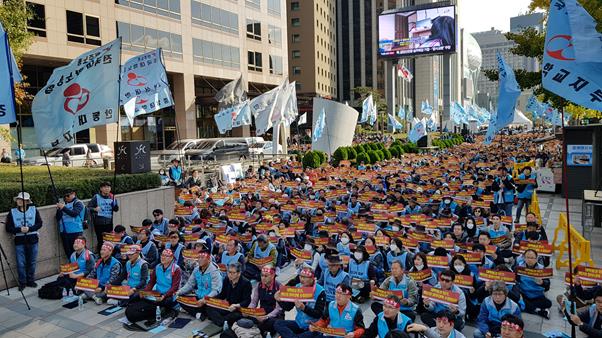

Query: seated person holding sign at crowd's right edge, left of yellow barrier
[516,249,552,319]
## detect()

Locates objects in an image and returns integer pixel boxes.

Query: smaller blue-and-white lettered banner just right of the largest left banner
[120,48,174,126]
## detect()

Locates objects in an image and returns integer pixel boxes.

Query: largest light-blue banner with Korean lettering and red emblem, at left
[31,38,121,149]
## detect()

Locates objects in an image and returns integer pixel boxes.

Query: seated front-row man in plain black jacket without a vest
[207,262,253,327]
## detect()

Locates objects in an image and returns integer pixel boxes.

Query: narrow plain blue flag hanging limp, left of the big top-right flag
[495,52,520,130]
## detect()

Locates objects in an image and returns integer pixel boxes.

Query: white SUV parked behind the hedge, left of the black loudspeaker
[23,143,115,167]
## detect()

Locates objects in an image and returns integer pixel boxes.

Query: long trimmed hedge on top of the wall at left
[0,166,161,212]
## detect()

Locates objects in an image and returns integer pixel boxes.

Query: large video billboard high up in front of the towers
[378,6,456,58]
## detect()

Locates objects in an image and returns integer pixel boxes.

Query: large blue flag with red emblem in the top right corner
[541,0,602,111]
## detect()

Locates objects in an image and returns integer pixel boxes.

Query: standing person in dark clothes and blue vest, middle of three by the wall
[55,188,86,257]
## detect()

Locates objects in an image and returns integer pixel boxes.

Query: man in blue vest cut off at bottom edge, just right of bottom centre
[363,295,413,338]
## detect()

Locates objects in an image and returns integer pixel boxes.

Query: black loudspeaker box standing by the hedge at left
[114,141,151,174]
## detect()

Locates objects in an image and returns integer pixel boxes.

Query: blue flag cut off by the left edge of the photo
[0,23,22,124]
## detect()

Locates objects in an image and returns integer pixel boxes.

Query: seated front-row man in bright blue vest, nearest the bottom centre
[299,284,366,338]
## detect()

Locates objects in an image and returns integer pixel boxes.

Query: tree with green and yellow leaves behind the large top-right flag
[483,0,602,119]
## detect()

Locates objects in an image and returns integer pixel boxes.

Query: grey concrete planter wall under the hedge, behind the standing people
[0,187,175,289]
